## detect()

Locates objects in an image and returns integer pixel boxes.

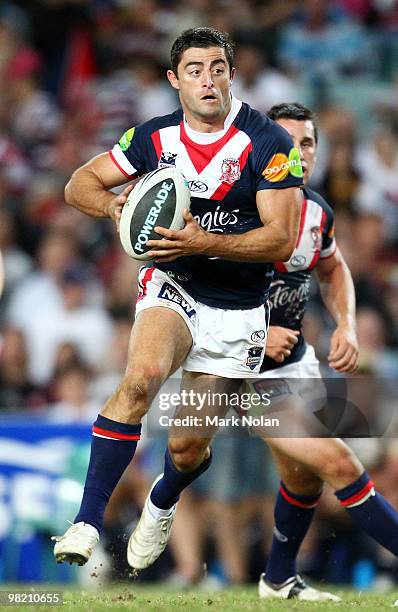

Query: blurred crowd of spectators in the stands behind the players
[0,0,398,582]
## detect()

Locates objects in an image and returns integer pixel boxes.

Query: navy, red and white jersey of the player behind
[261,187,336,372]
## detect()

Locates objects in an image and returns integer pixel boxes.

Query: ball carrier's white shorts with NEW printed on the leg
[136,268,269,378]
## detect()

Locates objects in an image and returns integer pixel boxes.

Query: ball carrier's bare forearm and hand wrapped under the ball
[148,187,302,262]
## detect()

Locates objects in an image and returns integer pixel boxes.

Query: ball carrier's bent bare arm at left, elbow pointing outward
[65,153,133,224]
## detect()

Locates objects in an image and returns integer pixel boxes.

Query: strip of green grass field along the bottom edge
[0,584,398,612]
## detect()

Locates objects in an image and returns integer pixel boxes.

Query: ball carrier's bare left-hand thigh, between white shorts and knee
[126,307,192,380]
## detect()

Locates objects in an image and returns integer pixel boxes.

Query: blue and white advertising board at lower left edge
[0,415,91,582]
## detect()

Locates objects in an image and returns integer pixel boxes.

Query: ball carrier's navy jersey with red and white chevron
[111,98,302,309]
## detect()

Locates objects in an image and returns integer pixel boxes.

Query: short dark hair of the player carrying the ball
[170,27,234,75]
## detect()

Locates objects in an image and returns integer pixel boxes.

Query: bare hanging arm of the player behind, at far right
[316,248,358,372]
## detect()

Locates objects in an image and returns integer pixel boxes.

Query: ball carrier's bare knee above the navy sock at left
[115,366,163,418]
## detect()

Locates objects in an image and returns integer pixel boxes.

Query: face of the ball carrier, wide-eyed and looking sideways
[167,47,235,128]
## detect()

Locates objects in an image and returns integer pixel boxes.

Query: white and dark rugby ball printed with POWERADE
[119,167,191,260]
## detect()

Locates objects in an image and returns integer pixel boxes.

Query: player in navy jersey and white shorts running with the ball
[54,28,302,568]
